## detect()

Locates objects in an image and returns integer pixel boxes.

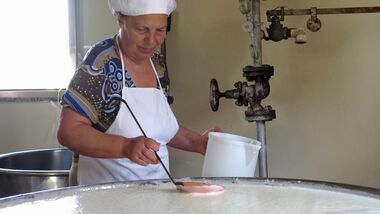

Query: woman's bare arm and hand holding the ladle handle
[57,107,160,165]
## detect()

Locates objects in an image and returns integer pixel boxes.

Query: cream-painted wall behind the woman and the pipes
[0,0,380,188]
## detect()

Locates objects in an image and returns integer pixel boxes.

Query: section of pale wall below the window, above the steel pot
[0,102,61,153]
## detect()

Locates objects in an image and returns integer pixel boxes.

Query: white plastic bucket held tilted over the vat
[202,132,261,177]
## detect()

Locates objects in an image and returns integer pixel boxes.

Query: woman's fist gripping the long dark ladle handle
[123,136,160,166]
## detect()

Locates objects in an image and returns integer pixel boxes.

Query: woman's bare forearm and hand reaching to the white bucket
[168,126,221,155]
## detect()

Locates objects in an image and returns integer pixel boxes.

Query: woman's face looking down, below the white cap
[119,14,168,60]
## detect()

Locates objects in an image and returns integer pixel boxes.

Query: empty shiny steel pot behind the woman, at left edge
[0,148,72,197]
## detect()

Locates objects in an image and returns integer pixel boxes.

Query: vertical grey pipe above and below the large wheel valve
[251,0,268,177]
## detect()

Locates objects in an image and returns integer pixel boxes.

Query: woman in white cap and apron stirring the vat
[58,0,220,184]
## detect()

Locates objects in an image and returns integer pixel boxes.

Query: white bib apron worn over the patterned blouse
[78,47,179,185]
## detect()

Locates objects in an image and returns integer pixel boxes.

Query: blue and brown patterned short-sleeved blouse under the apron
[61,36,173,132]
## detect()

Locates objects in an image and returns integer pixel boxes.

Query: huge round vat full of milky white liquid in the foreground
[0,178,380,214]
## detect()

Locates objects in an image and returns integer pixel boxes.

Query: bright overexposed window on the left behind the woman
[0,0,75,90]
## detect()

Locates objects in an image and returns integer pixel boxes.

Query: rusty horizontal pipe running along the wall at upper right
[267,7,380,16]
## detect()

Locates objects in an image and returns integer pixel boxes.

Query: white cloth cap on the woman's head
[108,0,176,16]
